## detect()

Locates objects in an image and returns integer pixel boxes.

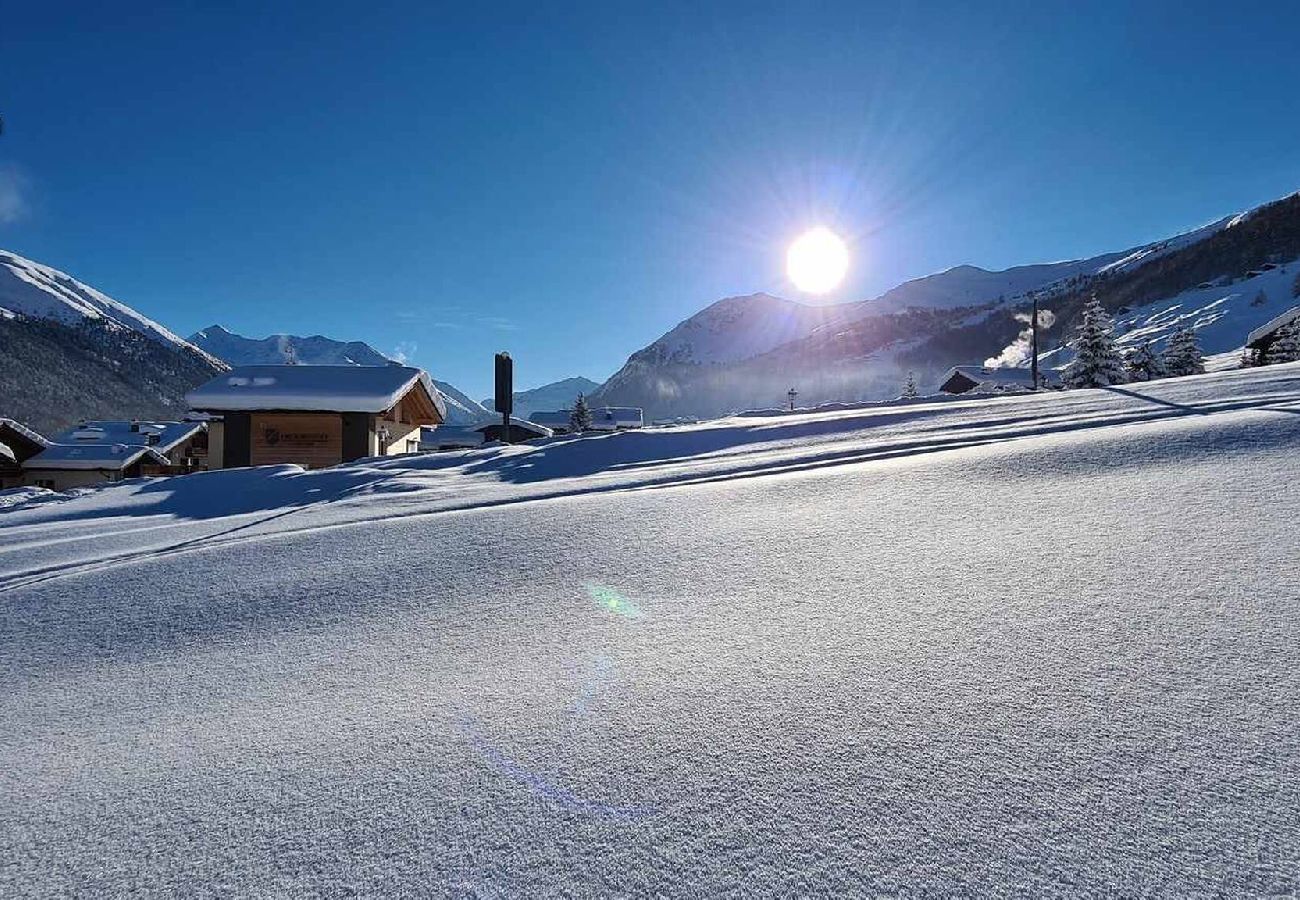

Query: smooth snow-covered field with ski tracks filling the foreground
[0,364,1300,897]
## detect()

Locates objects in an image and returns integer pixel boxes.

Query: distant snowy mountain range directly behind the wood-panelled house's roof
[190,325,493,425]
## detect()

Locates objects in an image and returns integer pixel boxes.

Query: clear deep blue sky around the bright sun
[0,3,1300,397]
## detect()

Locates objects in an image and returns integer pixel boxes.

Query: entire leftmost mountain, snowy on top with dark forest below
[0,251,225,432]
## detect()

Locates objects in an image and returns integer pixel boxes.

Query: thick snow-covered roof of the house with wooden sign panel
[185,365,447,419]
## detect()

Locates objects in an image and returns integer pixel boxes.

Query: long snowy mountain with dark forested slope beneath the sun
[593,188,1300,417]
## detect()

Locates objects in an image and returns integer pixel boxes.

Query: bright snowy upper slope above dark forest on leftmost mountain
[0,250,218,359]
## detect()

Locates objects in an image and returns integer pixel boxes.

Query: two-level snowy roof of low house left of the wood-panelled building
[25,421,204,470]
